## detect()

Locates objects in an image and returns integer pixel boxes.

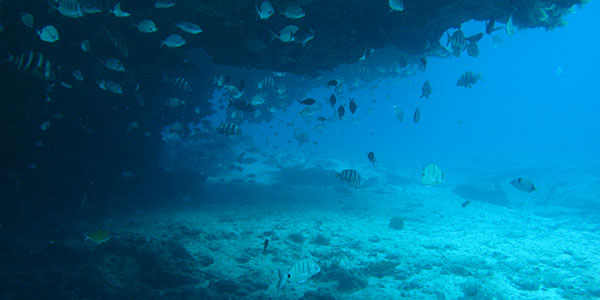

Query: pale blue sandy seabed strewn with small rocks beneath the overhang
[74,178,600,299]
